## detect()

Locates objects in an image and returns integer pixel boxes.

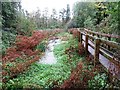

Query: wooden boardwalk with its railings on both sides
[69,28,120,79]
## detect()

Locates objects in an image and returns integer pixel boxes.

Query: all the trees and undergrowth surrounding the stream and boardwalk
[0,2,120,90]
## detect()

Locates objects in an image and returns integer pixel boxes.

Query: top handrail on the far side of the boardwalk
[84,28,120,39]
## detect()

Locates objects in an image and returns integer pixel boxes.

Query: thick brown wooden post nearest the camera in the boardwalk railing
[94,39,100,66]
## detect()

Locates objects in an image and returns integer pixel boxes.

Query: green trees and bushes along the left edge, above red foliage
[0,2,35,55]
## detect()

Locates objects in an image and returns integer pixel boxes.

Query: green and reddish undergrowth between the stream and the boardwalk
[3,33,118,90]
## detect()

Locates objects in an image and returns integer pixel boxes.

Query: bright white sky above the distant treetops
[21,0,80,13]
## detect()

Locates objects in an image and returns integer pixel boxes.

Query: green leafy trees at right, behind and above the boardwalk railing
[69,2,120,42]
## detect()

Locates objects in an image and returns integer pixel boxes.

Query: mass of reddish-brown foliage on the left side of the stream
[2,31,48,81]
